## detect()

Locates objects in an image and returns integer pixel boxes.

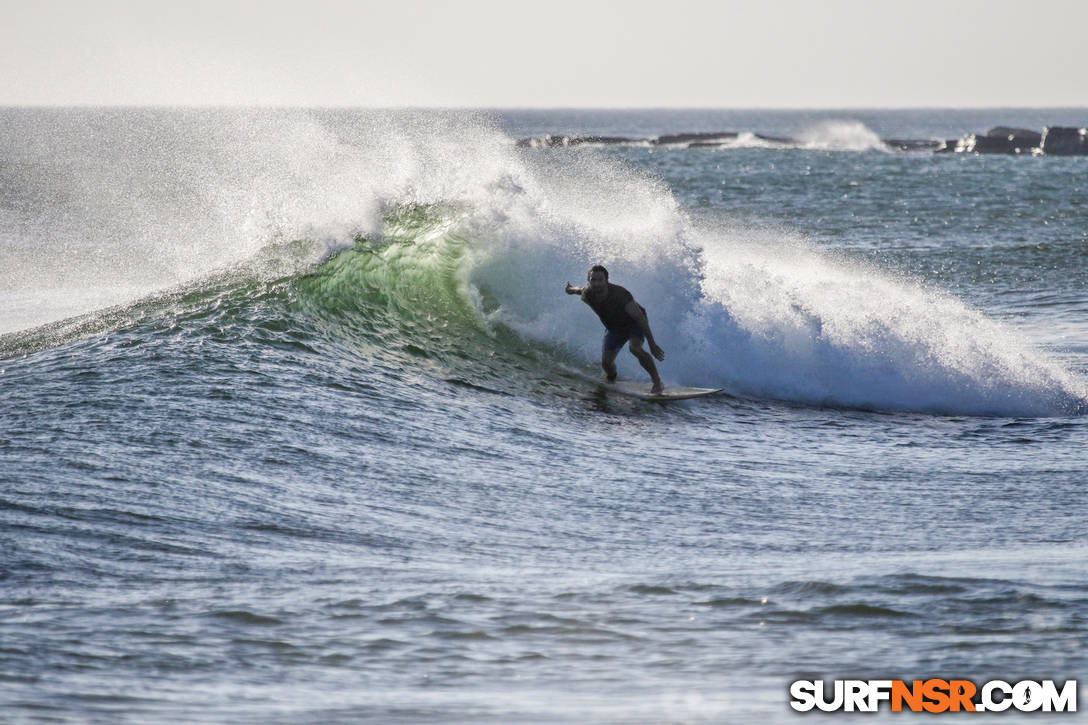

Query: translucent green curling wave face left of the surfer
[294,204,570,394]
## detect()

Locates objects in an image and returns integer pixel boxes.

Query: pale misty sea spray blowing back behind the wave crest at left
[0,109,499,332]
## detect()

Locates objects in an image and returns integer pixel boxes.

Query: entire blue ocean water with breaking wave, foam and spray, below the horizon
[0,109,1088,723]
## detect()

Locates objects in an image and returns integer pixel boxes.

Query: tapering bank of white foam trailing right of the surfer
[688,233,1085,415]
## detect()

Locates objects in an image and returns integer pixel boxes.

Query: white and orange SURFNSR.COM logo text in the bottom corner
[790,678,1077,713]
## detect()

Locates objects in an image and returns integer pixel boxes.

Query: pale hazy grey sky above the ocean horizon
[0,0,1088,108]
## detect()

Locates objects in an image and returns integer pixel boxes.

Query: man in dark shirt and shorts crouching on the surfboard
[567,265,665,395]
